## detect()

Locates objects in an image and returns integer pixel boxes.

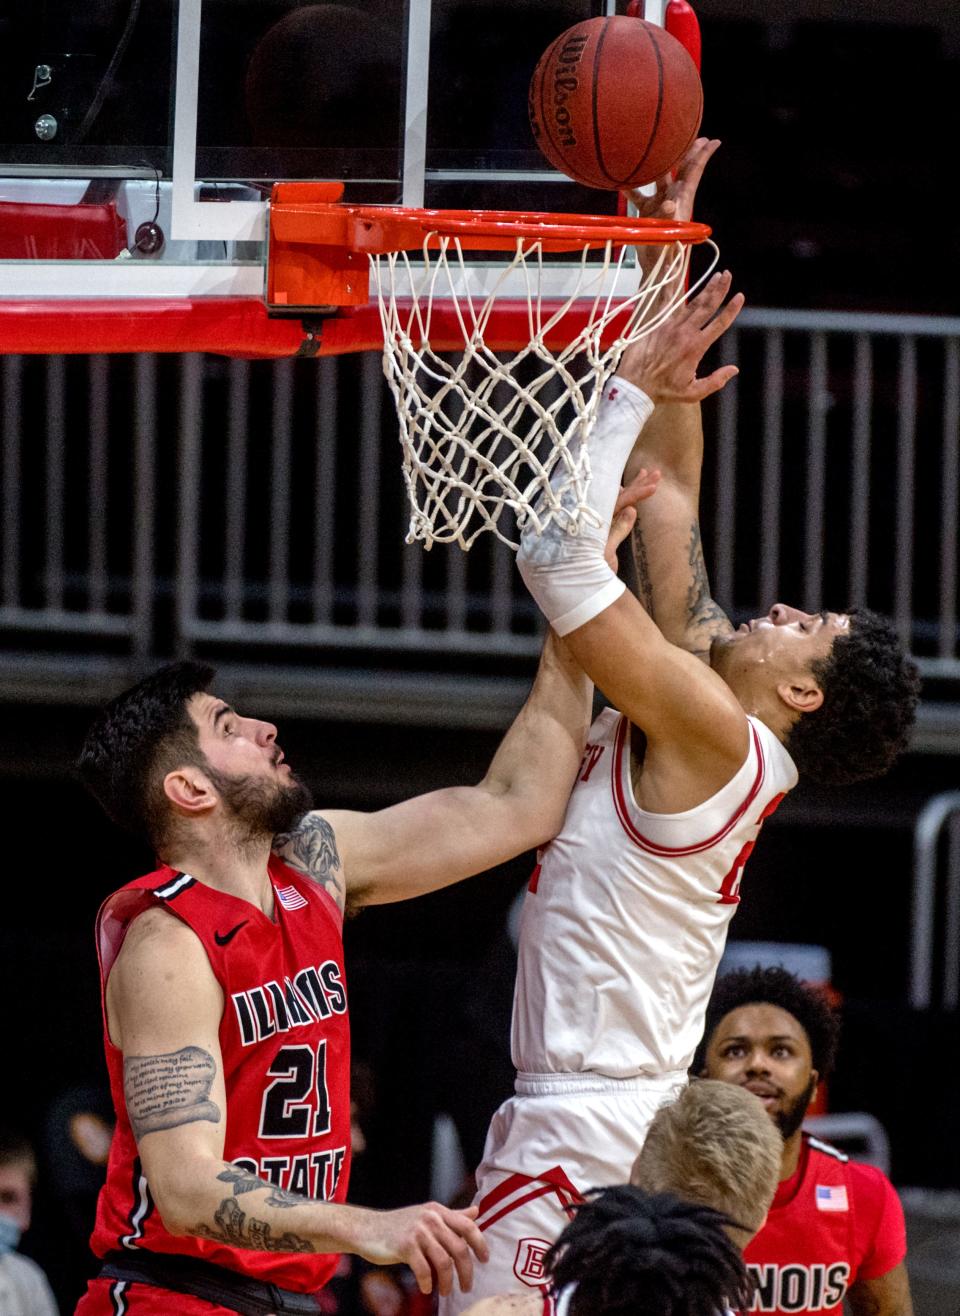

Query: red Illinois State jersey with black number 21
[91,855,350,1292]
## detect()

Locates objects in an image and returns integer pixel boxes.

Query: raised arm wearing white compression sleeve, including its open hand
[519,274,748,812]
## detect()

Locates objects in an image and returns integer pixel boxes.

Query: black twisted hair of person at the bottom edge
[545,1184,753,1316]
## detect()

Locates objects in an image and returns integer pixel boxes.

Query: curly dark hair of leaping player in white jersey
[786,608,920,786]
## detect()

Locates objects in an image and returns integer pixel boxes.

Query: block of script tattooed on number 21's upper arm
[124,1046,220,1138]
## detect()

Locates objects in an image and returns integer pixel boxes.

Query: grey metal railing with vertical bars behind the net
[0,303,960,726]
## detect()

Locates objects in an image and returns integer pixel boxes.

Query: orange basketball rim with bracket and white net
[267,183,716,549]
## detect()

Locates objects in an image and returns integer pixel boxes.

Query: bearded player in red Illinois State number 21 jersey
[78,618,652,1316]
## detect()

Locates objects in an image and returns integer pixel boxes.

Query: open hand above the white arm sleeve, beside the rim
[616,270,744,403]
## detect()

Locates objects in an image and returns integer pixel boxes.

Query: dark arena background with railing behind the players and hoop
[0,0,960,1316]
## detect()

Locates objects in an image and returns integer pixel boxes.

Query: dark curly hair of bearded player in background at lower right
[690,965,840,1079]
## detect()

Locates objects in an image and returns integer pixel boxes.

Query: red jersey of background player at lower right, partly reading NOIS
[744,1133,906,1316]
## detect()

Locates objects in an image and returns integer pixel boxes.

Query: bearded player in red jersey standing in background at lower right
[694,969,913,1316]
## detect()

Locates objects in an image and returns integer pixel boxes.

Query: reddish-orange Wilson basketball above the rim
[529,16,703,190]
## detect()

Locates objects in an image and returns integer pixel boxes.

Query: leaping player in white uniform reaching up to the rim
[441,141,917,1316]
